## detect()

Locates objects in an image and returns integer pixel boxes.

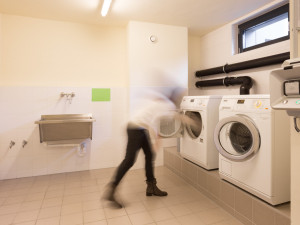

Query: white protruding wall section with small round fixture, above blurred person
[128,21,188,108]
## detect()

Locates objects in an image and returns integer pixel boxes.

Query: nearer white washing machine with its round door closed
[214,95,290,205]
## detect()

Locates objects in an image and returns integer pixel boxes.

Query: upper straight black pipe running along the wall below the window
[195,52,290,77]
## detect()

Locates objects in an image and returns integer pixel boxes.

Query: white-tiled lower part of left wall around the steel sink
[0,87,128,179]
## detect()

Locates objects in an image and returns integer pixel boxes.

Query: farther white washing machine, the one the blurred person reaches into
[180,96,222,170]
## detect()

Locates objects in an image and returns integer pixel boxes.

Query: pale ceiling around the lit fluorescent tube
[0,0,273,36]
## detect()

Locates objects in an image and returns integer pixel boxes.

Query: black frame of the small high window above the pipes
[238,3,290,53]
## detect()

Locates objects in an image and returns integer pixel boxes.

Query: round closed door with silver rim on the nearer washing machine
[214,115,260,161]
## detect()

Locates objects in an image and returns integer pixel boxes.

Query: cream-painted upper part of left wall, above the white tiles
[1,14,128,87]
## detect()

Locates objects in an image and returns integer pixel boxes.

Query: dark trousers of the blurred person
[113,127,154,186]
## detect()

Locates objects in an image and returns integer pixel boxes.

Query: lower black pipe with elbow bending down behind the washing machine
[195,76,253,95]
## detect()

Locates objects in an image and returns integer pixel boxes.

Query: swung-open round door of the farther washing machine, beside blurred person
[158,111,183,138]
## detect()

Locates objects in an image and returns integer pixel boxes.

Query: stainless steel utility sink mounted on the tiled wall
[35,114,96,143]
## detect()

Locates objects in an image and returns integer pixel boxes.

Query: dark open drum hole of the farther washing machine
[184,111,203,139]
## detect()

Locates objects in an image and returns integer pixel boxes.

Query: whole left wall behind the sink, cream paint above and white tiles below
[0,14,128,179]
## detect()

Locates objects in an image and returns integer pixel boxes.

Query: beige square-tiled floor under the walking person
[0,167,242,225]
